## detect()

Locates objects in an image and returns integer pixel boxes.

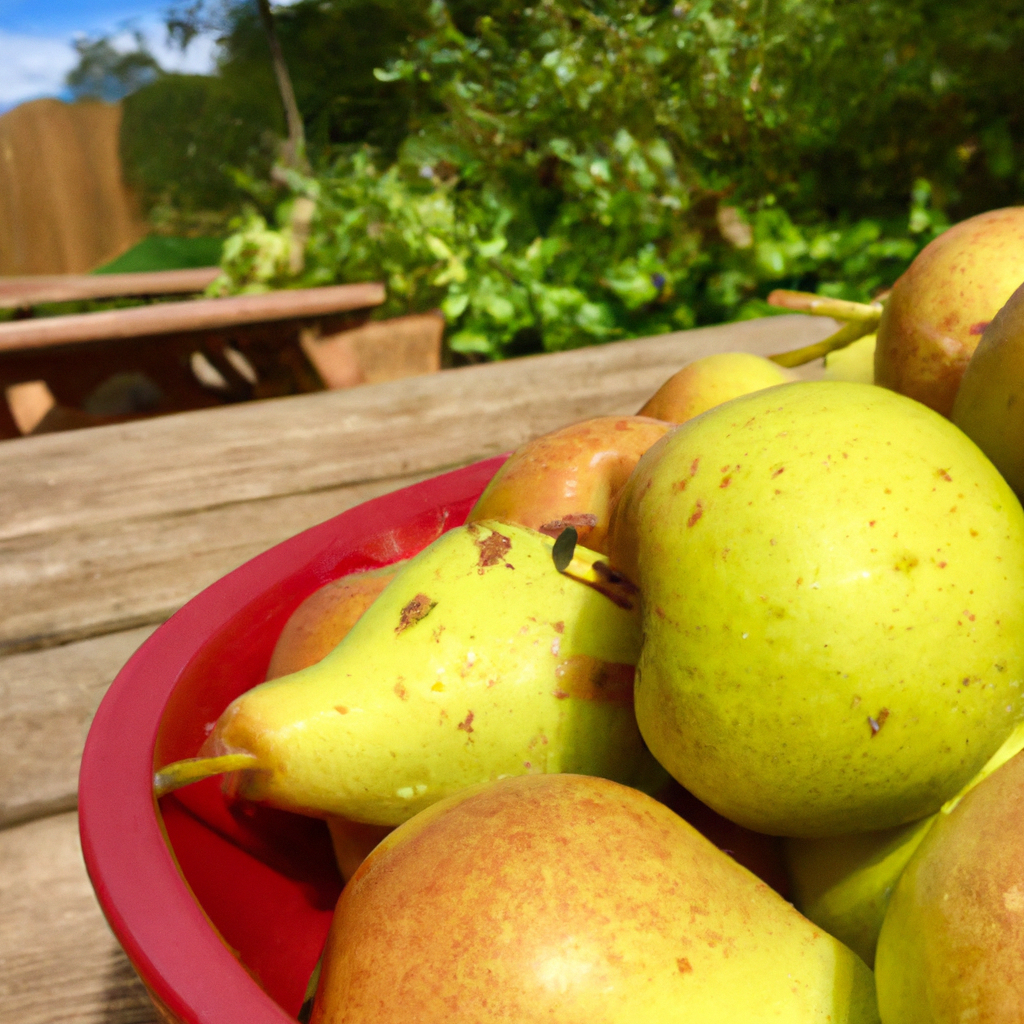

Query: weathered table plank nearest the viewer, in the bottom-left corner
[0,813,159,1024]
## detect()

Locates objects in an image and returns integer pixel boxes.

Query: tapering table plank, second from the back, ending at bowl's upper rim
[0,473,430,651]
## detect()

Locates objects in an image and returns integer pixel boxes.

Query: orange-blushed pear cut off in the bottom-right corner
[874,754,1024,1024]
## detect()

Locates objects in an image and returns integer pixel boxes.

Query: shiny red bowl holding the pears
[79,458,503,1024]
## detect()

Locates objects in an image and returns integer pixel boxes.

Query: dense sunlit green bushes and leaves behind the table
[121,0,1024,357]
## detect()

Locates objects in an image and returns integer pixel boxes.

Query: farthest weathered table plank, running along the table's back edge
[0,315,834,539]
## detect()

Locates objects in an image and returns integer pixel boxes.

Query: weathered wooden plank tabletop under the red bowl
[0,315,834,1024]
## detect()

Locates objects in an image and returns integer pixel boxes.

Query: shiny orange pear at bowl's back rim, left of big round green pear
[467,416,672,554]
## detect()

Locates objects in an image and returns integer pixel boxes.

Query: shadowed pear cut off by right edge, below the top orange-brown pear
[952,285,1024,495]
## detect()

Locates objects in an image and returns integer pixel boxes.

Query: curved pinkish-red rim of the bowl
[78,456,506,1024]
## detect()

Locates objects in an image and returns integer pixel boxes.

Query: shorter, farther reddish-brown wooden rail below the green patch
[0,266,220,309]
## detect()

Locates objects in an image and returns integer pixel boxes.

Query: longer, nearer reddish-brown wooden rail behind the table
[0,283,385,352]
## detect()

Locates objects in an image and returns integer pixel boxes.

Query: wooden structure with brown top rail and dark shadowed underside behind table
[0,282,385,438]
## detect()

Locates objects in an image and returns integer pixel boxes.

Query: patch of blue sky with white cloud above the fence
[0,0,215,112]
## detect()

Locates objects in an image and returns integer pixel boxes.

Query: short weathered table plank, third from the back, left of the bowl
[0,627,154,828]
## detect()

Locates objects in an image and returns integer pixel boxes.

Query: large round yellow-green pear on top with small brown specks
[612,381,1024,838]
